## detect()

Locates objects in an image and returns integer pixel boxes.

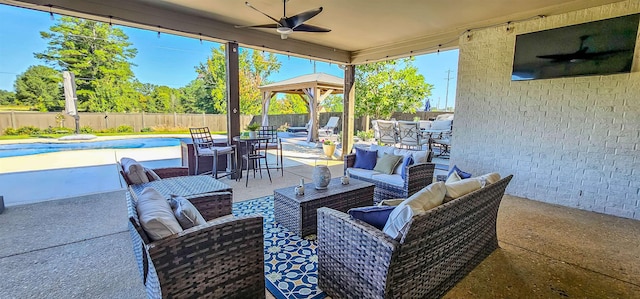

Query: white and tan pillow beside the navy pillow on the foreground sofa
[382,182,446,240]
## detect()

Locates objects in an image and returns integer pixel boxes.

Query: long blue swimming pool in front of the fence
[0,138,185,158]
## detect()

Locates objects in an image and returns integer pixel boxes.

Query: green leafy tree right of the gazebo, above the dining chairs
[355,58,433,119]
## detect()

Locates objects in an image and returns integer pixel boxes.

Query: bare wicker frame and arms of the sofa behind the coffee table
[344,154,436,204]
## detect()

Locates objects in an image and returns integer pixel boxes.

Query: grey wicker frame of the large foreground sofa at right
[317,176,512,298]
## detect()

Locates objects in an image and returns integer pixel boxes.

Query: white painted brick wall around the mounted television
[451,0,640,220]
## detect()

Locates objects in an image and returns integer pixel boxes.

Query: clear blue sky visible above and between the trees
[0,4,458,108]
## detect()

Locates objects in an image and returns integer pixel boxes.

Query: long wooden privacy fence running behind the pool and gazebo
[0,111,451,134]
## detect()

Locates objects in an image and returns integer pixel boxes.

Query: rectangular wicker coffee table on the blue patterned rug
[273,178,375,237]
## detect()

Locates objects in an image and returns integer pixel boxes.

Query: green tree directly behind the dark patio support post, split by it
[196,45,281,115]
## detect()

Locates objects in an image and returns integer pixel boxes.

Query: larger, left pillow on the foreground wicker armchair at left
[136,187,182,241]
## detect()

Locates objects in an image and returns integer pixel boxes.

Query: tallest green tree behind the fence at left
[34,17,138,112]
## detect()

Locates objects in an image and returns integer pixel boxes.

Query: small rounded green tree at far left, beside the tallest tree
[14,65,64,112]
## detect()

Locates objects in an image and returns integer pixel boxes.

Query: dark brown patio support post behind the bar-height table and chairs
[225,42,242,179]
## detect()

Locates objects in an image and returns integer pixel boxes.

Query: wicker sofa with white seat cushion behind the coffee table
[344,145,435,204]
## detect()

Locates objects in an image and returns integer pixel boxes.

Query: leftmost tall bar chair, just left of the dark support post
[189,127,237,179]
